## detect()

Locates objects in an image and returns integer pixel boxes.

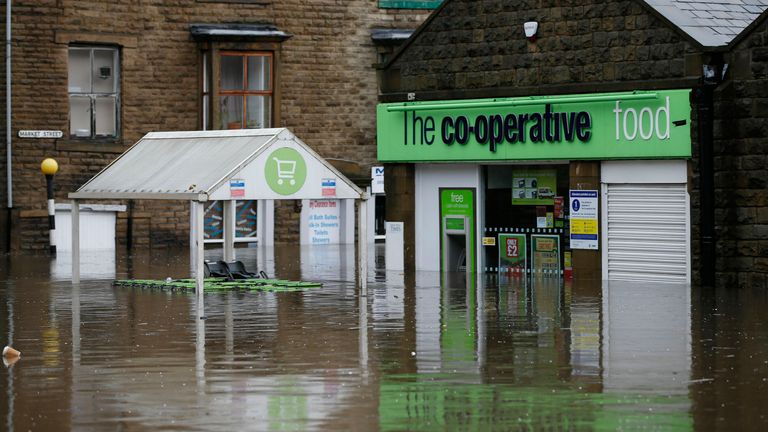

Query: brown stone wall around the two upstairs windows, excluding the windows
[0,0,429,250]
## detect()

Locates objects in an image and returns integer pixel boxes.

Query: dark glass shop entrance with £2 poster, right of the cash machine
[483,163,570,276]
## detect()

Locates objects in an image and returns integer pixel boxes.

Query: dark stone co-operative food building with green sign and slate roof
[377,0,768,287]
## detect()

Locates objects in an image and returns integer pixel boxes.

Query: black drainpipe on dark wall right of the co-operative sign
[697,64,728,287]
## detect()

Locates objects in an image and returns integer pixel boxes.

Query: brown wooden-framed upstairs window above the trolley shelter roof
[218,51,274,129]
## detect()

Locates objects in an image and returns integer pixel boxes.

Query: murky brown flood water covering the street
[0,246,768,431]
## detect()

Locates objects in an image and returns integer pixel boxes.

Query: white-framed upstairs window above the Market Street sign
[68,46,120,139]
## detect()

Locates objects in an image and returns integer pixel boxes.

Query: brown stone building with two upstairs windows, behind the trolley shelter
[0,0,432,251]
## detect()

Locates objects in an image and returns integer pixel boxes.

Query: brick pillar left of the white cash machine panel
[384,164,416,271]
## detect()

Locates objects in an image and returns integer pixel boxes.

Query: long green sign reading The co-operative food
[377,90,691,162]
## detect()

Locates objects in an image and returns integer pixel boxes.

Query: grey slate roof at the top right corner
[645,0,768,47]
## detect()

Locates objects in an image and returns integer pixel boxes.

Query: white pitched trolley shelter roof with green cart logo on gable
[69,128,363,201]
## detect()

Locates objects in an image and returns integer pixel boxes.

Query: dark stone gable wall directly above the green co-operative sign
[386,0,700,98]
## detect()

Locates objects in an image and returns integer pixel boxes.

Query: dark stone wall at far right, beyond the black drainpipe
[714,15,768,288]
